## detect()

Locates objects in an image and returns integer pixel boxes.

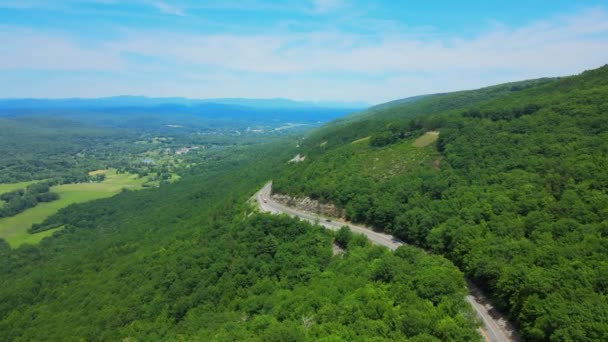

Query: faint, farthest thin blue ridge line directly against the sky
[0,96,369,110]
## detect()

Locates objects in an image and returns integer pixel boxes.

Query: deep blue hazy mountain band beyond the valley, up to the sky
[0,96,365,131]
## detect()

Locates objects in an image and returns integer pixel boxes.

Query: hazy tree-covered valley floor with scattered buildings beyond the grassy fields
[0,114,308,184]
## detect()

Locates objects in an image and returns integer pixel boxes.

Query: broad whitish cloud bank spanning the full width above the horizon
[0,9,608,102]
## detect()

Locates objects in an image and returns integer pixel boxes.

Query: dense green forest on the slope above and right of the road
[274,67,608,341]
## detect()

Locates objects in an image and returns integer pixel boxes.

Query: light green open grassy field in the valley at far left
[0,170,147,247]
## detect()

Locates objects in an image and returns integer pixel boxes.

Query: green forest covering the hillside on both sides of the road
[0,67,608,341]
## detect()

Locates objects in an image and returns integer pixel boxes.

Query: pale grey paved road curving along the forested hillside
[255,182,520,342]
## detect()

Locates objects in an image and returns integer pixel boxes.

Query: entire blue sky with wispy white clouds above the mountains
[0,0,608,103]
